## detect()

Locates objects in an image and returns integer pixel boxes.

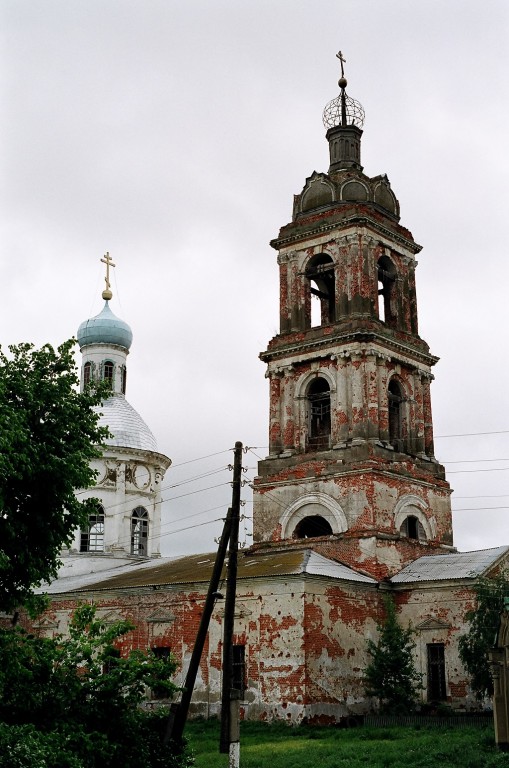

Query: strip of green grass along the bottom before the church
[186,720,509,768]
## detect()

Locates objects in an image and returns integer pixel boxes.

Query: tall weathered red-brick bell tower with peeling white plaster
[253,53,452,578]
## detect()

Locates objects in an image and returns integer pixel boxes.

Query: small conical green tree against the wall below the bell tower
[364,596,421,714]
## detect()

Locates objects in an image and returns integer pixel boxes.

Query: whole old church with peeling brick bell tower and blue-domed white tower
[33,54,509,723]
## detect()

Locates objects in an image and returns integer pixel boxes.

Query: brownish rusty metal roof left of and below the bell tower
[44,549,377,594]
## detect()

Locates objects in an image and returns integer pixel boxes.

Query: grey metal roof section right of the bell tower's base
[390,546,509,584]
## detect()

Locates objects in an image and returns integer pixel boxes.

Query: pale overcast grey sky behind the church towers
[0,0,509,555]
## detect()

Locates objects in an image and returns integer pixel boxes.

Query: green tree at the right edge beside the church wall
[458,571,509,700]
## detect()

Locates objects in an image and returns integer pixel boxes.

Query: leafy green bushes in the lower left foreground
[0,605,190,768]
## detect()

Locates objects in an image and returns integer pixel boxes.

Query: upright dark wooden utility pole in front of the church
[219,442,242,768]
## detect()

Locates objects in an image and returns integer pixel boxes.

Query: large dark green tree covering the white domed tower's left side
[0,340,108,611]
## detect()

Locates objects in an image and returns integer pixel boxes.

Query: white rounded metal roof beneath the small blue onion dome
[97,395,157,451]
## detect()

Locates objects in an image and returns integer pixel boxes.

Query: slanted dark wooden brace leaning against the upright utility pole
[164,507,233,744]
